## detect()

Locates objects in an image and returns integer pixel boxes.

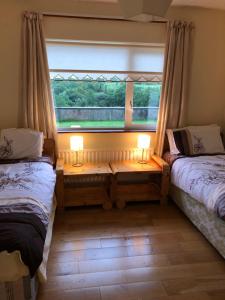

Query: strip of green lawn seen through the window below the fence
[57,120,156,128]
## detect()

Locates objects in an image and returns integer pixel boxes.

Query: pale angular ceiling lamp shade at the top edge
[119,0,172,22]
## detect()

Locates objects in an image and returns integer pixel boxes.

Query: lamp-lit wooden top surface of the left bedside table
[63,163,112,176]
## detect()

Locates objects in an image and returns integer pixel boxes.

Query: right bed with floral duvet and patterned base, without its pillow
[164,125,225,258]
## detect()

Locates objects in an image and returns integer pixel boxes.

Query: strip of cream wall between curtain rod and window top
[44,17,166,44]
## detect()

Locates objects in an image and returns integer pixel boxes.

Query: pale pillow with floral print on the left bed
[0,128,43,159]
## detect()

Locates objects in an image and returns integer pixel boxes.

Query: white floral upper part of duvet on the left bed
[0,162,56,218]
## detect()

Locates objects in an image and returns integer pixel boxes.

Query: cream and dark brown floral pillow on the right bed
[167,124,225,156]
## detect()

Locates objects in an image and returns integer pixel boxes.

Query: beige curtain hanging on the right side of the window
[156,21,193,156]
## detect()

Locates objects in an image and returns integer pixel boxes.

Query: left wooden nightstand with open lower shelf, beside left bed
[56,161,112,209]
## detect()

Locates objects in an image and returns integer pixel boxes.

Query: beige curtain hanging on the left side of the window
[21,12,57,145]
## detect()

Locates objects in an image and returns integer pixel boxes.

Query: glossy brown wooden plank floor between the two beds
[38,204,225,300]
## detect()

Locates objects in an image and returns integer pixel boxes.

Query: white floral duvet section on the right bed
[171,155,225,212]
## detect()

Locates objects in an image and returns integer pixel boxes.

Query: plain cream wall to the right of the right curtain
[168,8,225,130]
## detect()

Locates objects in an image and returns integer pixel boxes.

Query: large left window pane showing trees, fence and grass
[52,80,126,129]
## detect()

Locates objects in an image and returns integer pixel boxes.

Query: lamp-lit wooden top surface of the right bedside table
[110,160,162,174]
